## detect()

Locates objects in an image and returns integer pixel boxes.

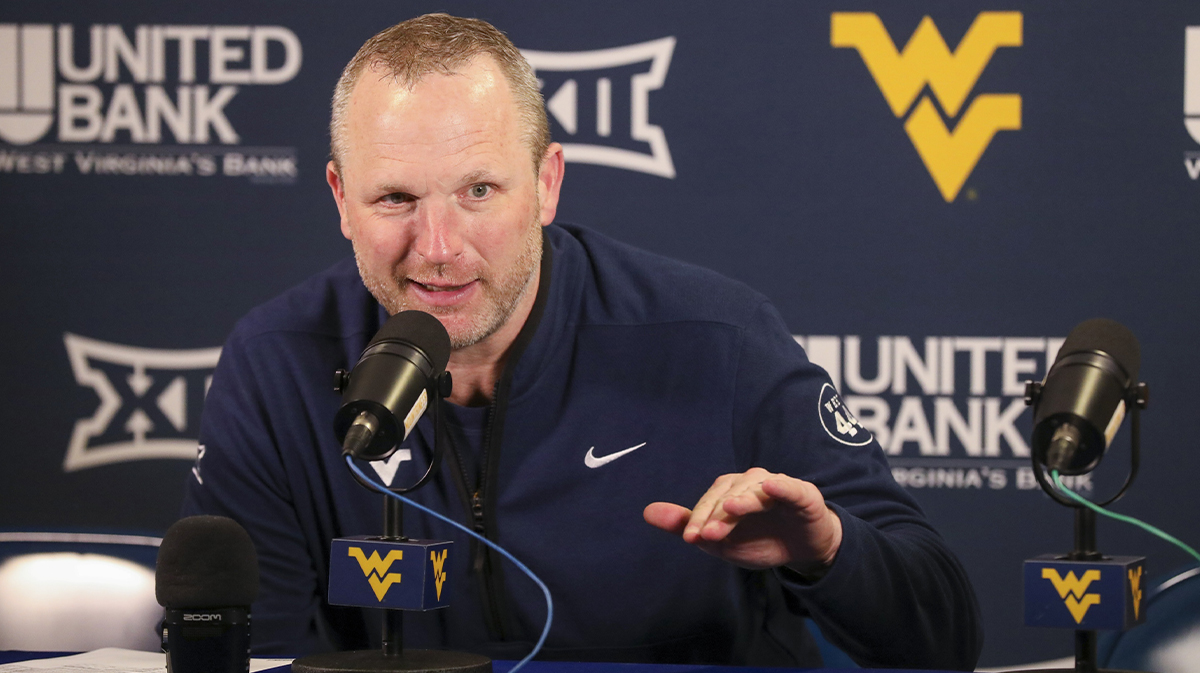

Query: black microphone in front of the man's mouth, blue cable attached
[334,311,450,461]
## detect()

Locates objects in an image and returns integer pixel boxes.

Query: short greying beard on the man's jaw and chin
[352,213,542,350]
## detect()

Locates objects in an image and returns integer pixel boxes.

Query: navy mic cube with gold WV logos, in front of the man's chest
[329,536,451,611]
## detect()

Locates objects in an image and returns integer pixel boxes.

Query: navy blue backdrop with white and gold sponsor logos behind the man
[0,0,1200,665]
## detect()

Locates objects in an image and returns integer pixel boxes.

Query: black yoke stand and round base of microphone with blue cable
[292,372,492,673]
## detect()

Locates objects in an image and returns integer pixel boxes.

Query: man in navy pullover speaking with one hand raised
[184,14,982,668]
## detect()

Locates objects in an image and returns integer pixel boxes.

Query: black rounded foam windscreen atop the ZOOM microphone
[155,516,258,609]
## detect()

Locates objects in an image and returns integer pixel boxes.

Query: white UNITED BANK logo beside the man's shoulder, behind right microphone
[794,335,1093,492]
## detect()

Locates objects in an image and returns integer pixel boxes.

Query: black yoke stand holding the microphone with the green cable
[1014,381,1150,673]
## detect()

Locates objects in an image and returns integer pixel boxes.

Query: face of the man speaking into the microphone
[326,56,562,348]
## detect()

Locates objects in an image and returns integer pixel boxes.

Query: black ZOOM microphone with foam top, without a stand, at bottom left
[155,516,258,673]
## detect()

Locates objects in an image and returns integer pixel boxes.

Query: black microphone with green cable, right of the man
[1032,318,1141,475]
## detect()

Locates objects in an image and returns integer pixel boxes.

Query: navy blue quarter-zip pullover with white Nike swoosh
[184,226,982,668]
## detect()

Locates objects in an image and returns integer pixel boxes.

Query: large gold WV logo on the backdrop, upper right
[830,12,1022,203]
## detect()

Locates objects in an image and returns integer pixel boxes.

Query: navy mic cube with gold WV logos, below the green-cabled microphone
[1025,554,1146,631]
